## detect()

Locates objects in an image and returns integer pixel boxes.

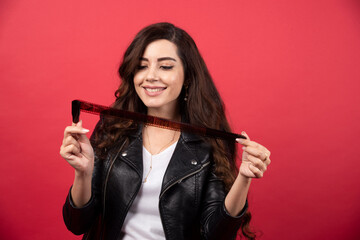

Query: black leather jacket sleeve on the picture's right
[201,172,248,239]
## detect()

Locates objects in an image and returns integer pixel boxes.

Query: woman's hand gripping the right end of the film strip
[236,132,271,178]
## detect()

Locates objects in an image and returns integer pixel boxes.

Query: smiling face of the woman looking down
[134,39,184,117]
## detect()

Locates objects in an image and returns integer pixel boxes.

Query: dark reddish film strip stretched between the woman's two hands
[72,100,246,141]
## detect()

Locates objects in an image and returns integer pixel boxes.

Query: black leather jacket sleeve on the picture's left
[63,120,104,235]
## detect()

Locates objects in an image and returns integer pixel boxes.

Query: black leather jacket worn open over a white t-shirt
[63,124,247,240]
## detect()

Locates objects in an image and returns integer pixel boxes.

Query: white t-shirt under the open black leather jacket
[122,142,177,240]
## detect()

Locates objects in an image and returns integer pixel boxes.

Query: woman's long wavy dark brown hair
[93,23,255,239]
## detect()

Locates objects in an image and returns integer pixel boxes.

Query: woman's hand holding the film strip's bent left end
[60,121,94,176]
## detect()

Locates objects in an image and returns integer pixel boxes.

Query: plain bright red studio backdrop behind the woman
[0,0,360,240]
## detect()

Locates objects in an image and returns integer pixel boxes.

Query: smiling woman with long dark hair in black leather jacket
[60,23,270,239]
